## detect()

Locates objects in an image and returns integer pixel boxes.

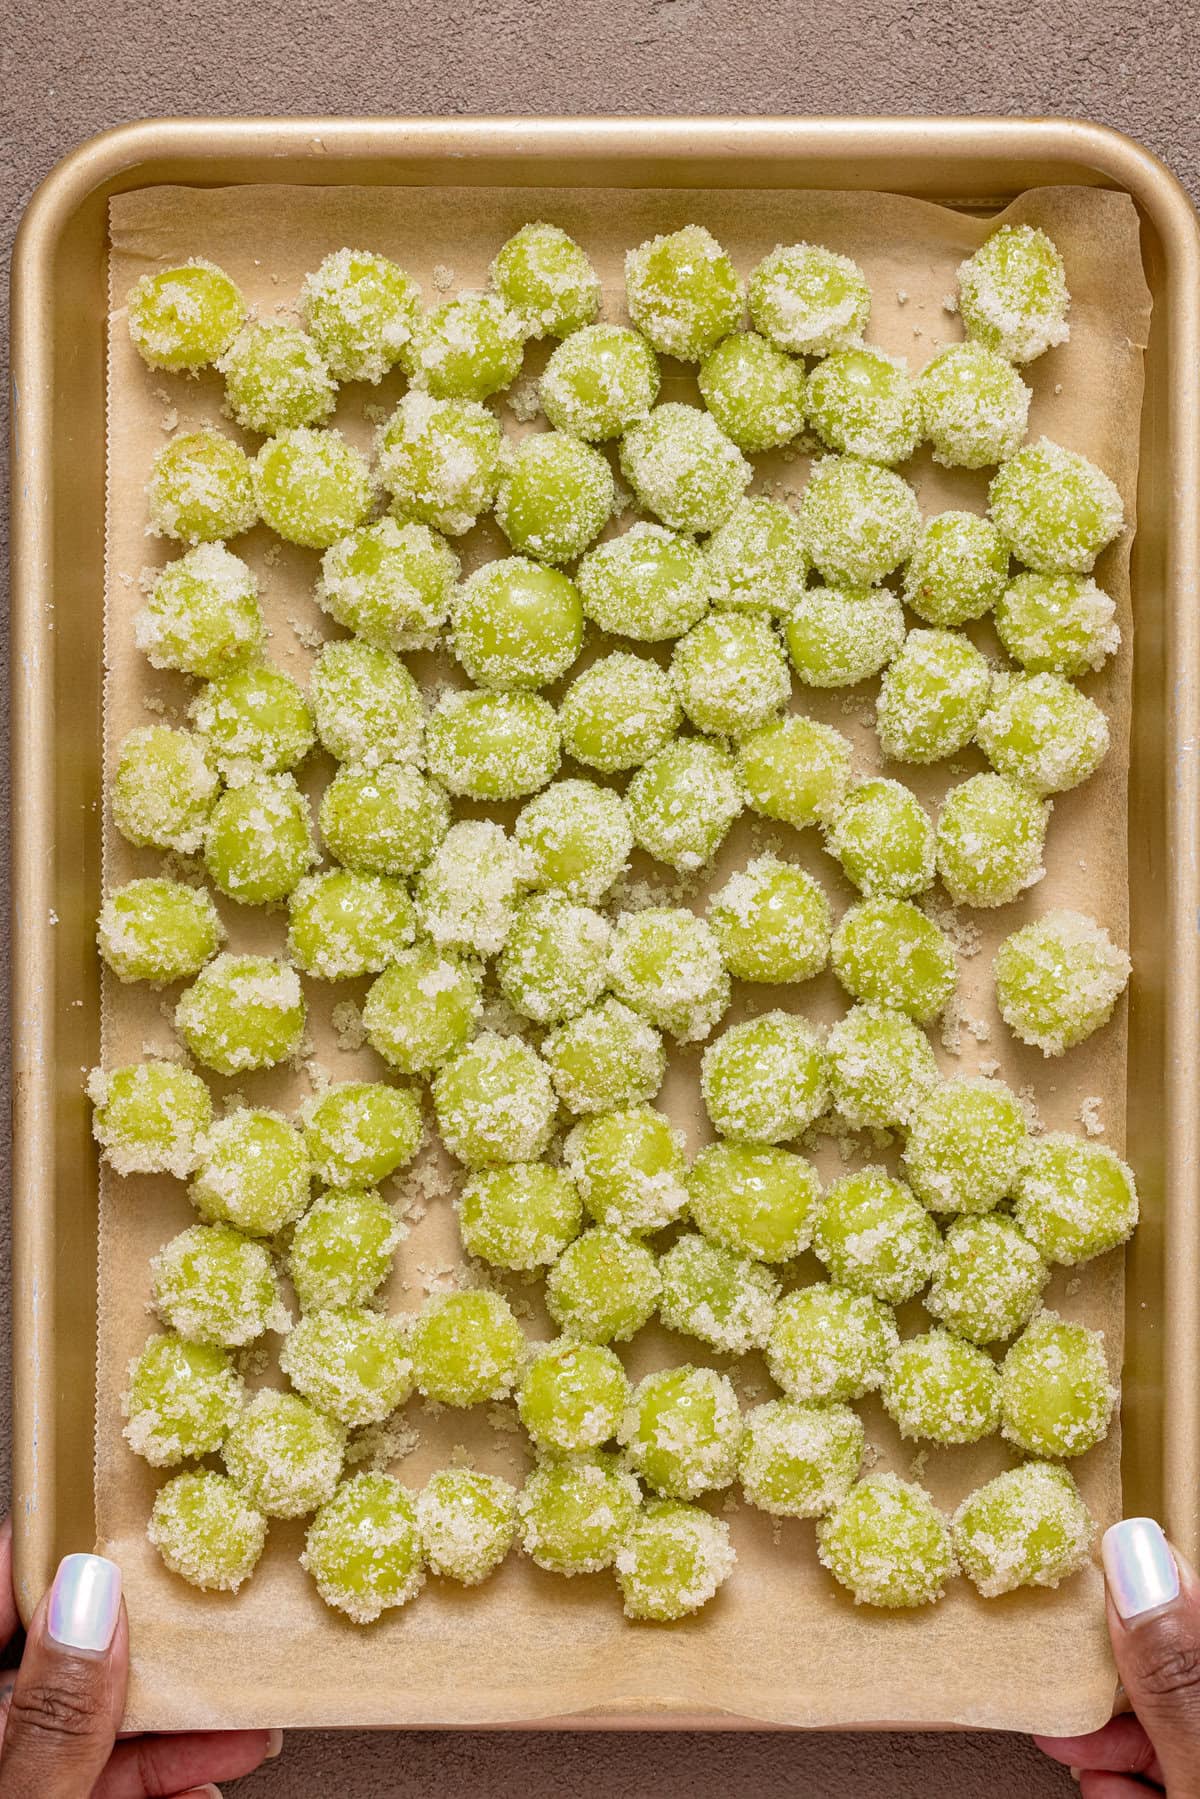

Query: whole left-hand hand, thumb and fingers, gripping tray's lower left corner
[0,1518,282,1799]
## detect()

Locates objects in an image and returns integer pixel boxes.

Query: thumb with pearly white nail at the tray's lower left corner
[0,1556,130,1799]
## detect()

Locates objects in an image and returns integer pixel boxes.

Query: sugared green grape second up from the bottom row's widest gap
[766,1281,900,1403]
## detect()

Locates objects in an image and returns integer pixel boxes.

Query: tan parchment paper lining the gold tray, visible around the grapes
[95,185,1150,1732]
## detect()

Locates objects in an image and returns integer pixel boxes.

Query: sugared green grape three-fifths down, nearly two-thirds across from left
[700,1011,829,1142]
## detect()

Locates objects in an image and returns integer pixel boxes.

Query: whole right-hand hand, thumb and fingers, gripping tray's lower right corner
[1036,1518,1200,1799]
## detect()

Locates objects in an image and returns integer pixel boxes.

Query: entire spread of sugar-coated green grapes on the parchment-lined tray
[90,223,1137,1623]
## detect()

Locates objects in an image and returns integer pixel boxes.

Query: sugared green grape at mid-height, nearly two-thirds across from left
[707,856,831,982]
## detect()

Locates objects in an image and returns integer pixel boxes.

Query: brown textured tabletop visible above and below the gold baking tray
[0,0,1200,1799]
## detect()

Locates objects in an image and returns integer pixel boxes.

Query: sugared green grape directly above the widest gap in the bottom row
[738,1400,865,1518]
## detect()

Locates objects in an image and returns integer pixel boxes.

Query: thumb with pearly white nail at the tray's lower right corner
[1101,1518,1200,1795]
